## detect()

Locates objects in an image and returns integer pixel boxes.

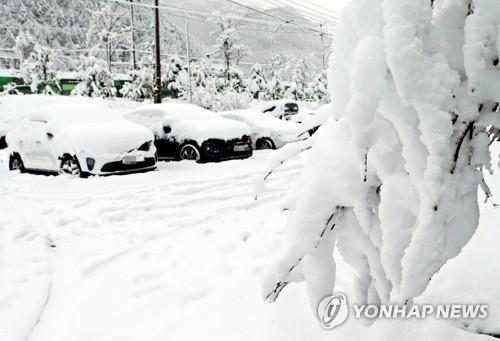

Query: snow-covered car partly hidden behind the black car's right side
[219,109,309,150]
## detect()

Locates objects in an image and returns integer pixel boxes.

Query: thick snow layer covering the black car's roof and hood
[123,102,250,144]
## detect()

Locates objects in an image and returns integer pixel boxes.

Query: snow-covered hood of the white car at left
[54,120,154,156]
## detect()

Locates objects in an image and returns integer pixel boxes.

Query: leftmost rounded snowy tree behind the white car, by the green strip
[21,44,57,94]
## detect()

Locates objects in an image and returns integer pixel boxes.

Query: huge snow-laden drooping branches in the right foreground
[264,0,500,322]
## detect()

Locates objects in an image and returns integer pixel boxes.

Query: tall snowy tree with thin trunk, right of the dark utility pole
[208,11,250,81]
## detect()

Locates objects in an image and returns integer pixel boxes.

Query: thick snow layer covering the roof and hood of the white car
[1,96,153,156]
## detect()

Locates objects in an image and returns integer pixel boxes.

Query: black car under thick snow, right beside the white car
[124,102,253,162]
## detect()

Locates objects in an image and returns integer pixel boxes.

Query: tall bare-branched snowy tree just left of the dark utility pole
[87,1,130,71]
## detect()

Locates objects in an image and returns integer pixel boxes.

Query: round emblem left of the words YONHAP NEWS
[318,294,349,329]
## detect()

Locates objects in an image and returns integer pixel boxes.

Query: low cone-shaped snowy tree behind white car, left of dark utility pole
[72,56,116,97]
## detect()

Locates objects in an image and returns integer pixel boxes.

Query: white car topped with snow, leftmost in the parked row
[6,105,156,177]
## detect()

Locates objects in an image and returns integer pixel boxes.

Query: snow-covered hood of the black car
[169,118,250,144]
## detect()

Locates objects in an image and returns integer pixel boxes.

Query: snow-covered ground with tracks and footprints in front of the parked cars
[0,152,500,341]
